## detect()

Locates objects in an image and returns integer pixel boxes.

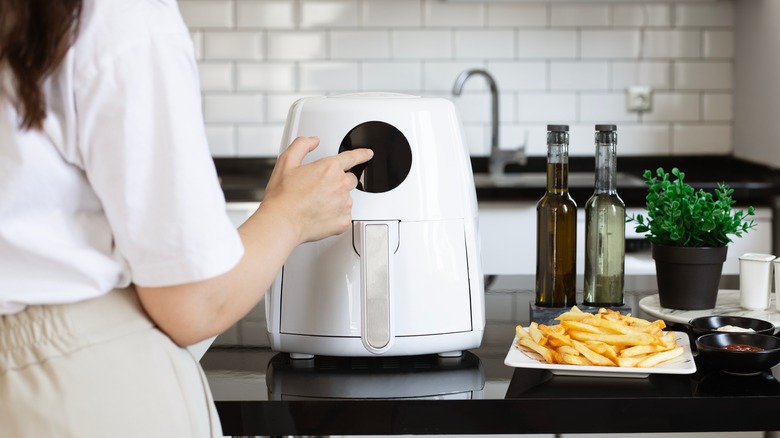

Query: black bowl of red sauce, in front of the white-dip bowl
[696,332,780,374]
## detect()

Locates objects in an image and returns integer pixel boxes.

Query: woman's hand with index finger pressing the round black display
[260,137,373,243]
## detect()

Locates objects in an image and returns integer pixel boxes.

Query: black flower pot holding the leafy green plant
[652,244,728,310]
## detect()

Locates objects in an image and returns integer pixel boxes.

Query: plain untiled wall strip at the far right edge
[734,0,780,168]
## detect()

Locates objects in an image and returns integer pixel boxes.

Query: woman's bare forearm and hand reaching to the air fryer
[136,137,373,346]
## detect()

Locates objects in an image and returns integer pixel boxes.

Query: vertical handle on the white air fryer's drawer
[352,221,398,354]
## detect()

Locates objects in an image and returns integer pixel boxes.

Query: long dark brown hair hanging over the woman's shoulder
[0,0,83,129]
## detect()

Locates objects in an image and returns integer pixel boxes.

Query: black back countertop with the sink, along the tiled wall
[215,156,780,207]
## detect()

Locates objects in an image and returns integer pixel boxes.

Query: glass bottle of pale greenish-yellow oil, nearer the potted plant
[583,125,626,307]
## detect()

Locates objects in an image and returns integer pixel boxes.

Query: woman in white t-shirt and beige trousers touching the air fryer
[0,0,371,437]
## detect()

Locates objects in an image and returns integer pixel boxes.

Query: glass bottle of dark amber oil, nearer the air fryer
[536,125,577,307]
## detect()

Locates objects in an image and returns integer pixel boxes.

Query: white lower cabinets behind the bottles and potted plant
[479,201,772,275]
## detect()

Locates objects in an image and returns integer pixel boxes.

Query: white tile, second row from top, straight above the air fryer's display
[330,30,390,59]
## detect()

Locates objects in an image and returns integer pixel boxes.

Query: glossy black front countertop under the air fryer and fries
[201,276,780,436]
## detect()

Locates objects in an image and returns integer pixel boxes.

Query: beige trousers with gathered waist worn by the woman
[0,288,222,438]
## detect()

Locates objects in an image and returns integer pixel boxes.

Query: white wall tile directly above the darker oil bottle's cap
[517,93,577,124]
